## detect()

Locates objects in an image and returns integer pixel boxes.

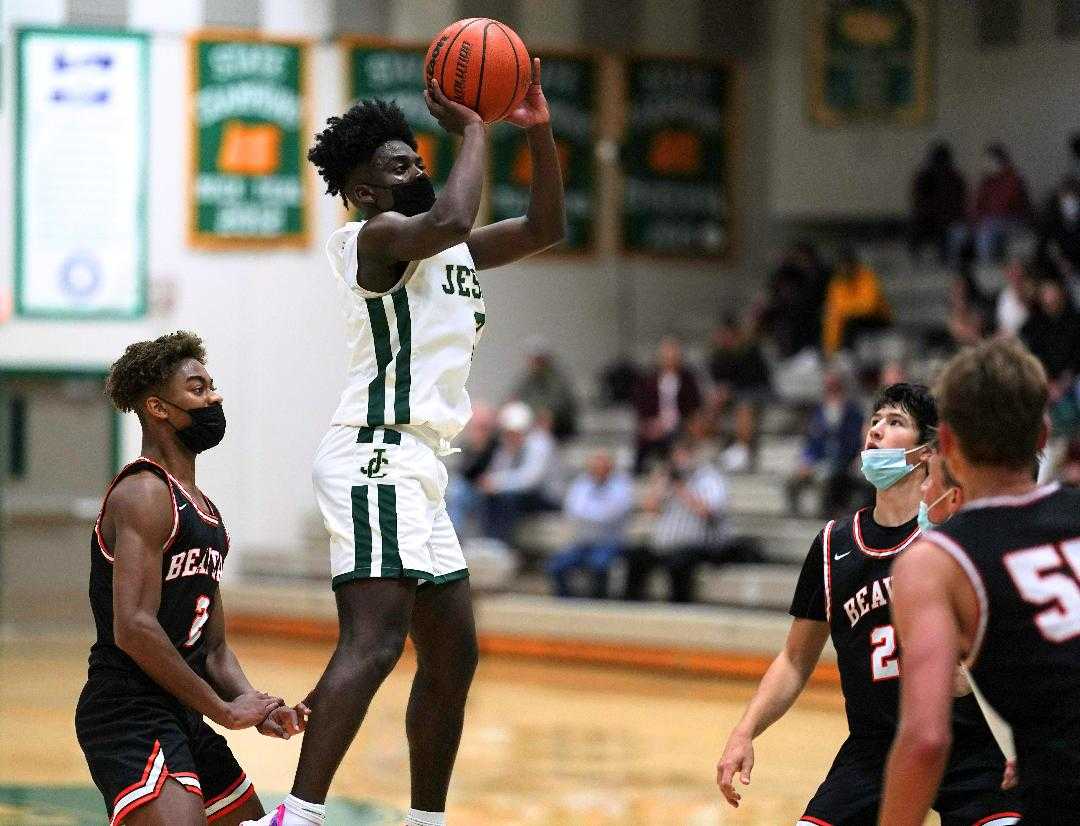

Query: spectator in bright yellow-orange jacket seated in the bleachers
[822,246,892,357]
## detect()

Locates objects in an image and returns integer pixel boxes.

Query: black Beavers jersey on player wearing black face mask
[90,458,229,689]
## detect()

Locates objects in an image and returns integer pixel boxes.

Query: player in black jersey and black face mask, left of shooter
[75,331,307,826]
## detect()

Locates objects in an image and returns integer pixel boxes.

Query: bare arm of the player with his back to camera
[880,541,974,826]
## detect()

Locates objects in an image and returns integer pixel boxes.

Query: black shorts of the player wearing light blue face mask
[798,737,1021,826]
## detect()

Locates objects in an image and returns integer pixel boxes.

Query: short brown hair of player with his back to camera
[937,339,1048,470]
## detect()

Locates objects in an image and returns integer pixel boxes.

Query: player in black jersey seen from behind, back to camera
[880,339,1080,826]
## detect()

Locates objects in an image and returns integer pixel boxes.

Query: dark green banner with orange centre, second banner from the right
[622,58,733,256]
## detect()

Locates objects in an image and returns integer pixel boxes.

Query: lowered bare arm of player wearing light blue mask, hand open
[716,620,829,809]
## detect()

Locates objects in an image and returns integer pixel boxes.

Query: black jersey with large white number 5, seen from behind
[927,484,1080,799]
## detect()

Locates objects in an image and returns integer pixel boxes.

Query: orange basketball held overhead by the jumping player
[423,17,532,123]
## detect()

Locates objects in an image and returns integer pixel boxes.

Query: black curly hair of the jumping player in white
[308,99,416,206]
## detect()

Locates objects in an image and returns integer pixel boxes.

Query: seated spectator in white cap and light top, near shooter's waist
[477,402,558,545]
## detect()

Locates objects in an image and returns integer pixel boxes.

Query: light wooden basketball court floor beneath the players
[0,634,936,826]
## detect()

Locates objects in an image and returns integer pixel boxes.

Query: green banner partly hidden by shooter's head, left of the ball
[346,40,454,187]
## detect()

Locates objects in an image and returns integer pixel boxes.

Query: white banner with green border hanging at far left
[14,28,150,319]
